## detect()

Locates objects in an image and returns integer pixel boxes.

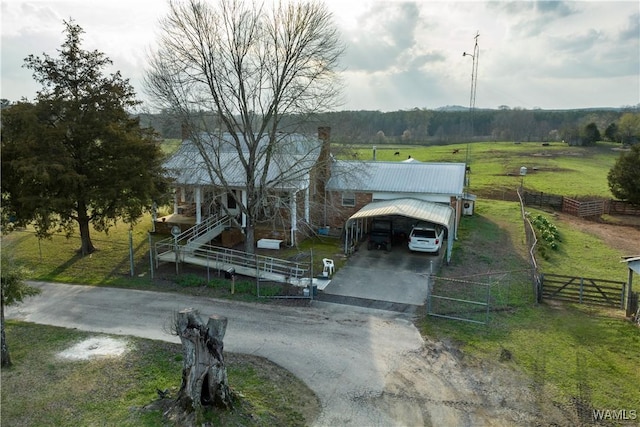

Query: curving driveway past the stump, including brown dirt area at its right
[5,282,564,427]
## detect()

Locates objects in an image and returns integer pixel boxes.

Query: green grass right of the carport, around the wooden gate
[419,201,640,420]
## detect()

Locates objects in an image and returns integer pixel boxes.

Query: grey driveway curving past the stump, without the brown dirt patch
[6,282,423,426]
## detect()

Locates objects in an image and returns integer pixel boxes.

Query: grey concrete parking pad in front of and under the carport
[319,245,443,311]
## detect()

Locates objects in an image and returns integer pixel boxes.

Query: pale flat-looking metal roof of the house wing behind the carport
[327,160,466,195]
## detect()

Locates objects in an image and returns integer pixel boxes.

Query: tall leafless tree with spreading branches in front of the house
[146,0,343,252]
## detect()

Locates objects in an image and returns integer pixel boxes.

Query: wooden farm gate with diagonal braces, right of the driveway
[541,273,627,309]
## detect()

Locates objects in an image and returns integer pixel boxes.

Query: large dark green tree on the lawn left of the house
[2,21,166,254]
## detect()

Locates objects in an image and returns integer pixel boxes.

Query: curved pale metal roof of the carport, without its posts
[349,198,453,228]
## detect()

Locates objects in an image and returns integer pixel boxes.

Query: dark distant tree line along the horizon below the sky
[141,106,640,145]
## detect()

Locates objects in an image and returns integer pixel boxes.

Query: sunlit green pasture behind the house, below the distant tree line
[355,142,619,198]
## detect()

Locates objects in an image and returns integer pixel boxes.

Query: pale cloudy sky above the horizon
[0,0,640,111]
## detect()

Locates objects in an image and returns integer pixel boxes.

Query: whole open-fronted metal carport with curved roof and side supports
[345,198,457,263]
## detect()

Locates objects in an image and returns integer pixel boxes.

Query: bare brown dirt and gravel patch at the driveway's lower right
[369,341,579,426]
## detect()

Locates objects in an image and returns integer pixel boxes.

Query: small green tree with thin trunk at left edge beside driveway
[0,254,40,366]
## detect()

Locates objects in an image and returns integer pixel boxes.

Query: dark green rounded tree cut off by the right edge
[607,144,640,205]
